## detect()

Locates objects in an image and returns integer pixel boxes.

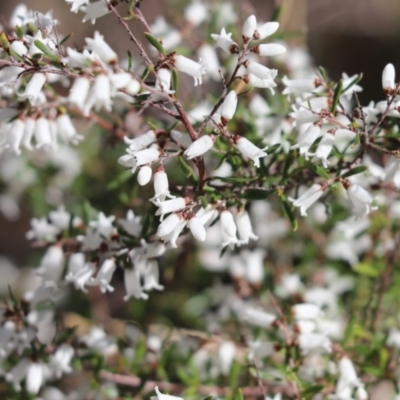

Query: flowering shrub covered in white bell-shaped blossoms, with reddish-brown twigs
[0,0,400,400]
